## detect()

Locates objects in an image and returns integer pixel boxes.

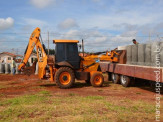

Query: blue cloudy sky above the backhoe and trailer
[0,0,163,54]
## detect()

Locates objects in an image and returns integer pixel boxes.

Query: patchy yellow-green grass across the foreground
[0,90,155,122]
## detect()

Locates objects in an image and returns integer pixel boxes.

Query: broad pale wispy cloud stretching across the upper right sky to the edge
[78,5,163,30]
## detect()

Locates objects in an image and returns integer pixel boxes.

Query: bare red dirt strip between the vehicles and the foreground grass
[0,75,161,102]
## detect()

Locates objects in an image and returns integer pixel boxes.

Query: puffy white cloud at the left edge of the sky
[0,17,14,30]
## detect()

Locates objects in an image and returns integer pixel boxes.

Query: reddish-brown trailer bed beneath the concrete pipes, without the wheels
[100,62,163,82]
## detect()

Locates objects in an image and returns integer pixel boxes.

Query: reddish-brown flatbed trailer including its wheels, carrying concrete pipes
[100,62,163,87]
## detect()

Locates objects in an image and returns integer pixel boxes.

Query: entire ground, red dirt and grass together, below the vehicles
[0,74,163,122]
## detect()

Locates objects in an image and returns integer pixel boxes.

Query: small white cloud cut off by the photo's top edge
[30,0,56,8]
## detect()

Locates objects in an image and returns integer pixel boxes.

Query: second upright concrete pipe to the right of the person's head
[144,44,151,66]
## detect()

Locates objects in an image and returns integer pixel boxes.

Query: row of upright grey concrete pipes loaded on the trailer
[118,42,163,67]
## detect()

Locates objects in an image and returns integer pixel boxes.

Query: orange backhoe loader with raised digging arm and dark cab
[18,28,122,88]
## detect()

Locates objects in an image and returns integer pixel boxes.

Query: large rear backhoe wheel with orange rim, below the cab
[55,67,75,89]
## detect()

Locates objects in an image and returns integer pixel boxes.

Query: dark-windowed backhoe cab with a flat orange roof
[53,40,80,69]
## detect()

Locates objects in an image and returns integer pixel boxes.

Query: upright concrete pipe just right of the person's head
[138,44,145,65]
